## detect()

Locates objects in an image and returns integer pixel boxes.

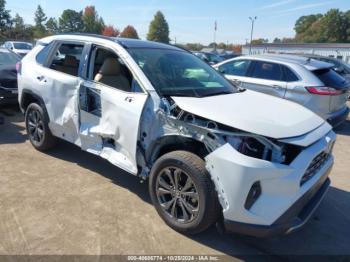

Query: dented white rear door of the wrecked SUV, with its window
[33,41,85,145]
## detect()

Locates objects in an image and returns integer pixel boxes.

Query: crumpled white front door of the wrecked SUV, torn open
[79,45,148,174]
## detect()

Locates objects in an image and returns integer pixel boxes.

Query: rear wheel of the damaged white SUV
[25,103,56,151]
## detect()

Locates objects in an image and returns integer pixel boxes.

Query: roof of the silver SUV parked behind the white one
[237,54,333,71]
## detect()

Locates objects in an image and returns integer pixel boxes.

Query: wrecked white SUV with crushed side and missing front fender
[18,35,335,236]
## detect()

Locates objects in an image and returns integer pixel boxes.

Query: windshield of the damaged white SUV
[128,48,236,97]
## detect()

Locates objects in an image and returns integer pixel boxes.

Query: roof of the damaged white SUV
[39,33,184,51]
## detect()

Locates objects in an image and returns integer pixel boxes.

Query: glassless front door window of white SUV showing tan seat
[88,46,142,92]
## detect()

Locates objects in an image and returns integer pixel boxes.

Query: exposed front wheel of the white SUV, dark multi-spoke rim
[149,151,219,234]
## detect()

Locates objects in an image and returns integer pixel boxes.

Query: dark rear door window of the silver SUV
[251,61,283,81]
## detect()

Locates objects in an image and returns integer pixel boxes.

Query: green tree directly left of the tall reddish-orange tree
[58,9,84,33]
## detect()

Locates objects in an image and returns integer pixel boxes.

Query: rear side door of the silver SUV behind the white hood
[243,60,287,98]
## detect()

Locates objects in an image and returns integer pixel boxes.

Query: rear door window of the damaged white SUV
[49,43,84,76]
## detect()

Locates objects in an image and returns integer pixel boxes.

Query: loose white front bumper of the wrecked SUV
[206,131,335,237]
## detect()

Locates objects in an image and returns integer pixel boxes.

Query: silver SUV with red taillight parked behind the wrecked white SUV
[214,55,350,126]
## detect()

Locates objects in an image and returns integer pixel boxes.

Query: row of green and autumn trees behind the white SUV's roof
[0,0,170,43]
